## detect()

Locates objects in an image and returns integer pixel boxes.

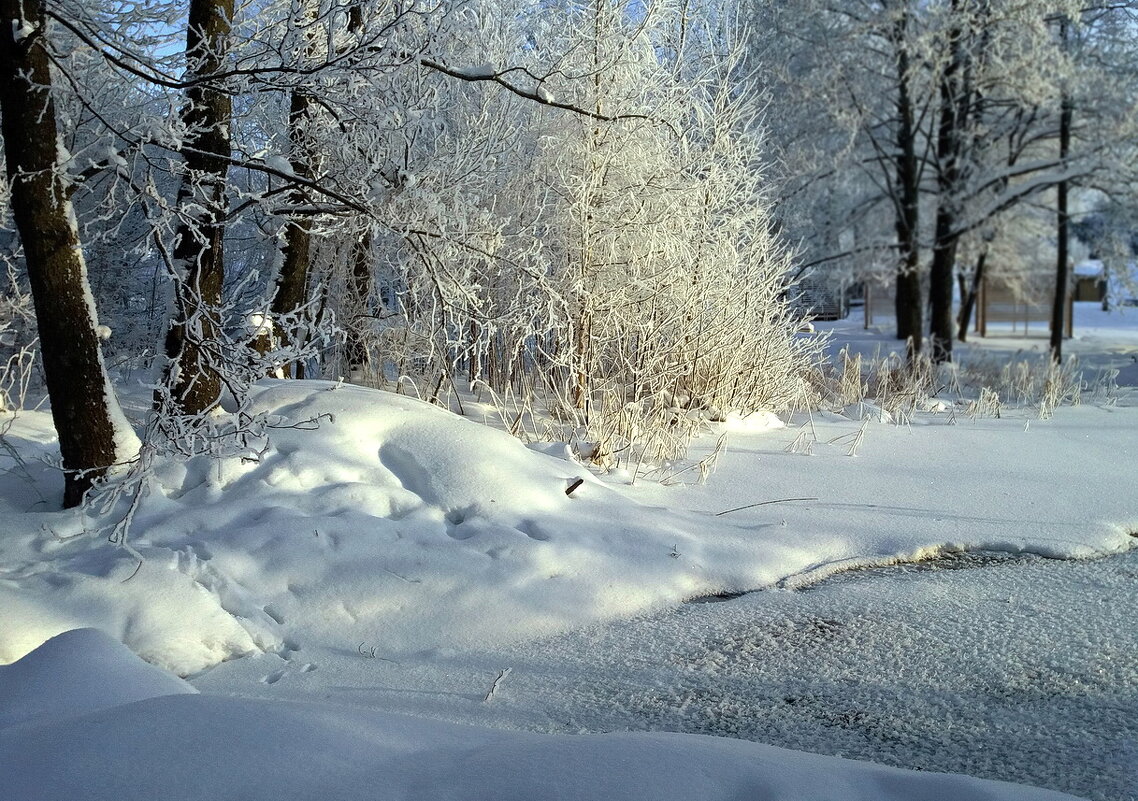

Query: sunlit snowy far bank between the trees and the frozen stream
[0,373,1133,676]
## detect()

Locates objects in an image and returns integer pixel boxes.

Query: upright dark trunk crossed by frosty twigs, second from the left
[166,0,233,414]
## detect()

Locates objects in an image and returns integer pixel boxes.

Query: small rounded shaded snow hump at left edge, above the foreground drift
[0,628,198,728]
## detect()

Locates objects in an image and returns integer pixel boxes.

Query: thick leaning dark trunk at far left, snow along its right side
[0,0,126,506]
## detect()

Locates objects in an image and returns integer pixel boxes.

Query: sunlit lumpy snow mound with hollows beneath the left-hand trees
[0,381,708,676]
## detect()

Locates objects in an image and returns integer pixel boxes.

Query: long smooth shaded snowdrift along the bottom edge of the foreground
[0,695,1072,801]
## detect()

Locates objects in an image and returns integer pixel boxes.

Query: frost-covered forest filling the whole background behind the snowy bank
[0,0,1138,505]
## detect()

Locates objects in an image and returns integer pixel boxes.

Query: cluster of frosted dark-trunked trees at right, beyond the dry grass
[752,0,1136,361]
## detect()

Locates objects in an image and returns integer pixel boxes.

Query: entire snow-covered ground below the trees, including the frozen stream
[0,306,1138,800]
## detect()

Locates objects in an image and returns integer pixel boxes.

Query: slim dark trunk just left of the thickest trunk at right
[892,10,923,357]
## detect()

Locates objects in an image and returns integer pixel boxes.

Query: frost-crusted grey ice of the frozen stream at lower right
[473,551,1138,801]
